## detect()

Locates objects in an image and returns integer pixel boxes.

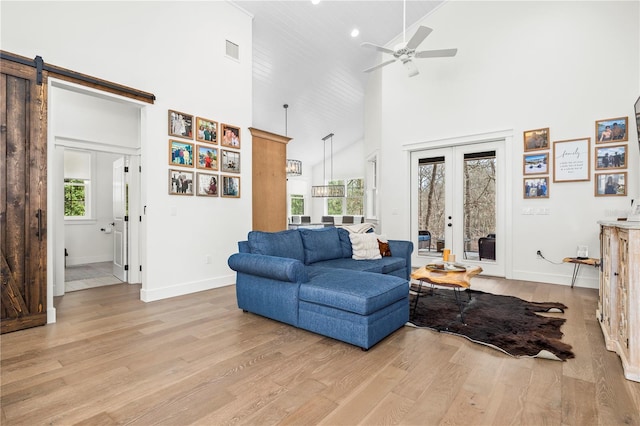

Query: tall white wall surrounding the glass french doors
[366,1,640,287]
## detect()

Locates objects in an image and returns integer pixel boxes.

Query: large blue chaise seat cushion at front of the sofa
[298,269,409,315]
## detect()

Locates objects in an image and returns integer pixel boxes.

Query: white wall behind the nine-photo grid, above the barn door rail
[1,1,252,301]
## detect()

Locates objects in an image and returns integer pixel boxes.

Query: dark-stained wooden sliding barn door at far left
[0,56,47,333]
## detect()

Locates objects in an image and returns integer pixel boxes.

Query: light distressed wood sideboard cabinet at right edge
[596,221,640,382]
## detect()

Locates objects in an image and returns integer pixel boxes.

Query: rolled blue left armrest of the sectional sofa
[227,253,309,283]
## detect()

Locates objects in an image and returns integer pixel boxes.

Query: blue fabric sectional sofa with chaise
[228,227,413,350]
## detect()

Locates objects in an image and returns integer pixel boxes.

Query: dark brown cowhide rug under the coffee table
[407,287,574,361]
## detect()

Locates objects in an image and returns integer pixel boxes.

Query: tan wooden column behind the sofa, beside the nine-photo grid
[249,127,291,232]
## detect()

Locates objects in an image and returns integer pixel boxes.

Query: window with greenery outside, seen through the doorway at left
[64,149,93,219]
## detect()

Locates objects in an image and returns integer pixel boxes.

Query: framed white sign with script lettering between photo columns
[553,138,591,182]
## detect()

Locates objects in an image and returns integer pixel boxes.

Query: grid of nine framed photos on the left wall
[168,110,241,198]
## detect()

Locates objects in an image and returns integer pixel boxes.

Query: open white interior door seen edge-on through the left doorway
[112,157,128,282]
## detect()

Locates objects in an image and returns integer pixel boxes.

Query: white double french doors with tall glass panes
[411,141,505,276]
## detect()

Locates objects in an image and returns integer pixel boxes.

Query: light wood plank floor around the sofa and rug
[0,277,640,425]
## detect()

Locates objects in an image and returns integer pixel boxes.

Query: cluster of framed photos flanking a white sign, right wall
[522,117,629,199]
